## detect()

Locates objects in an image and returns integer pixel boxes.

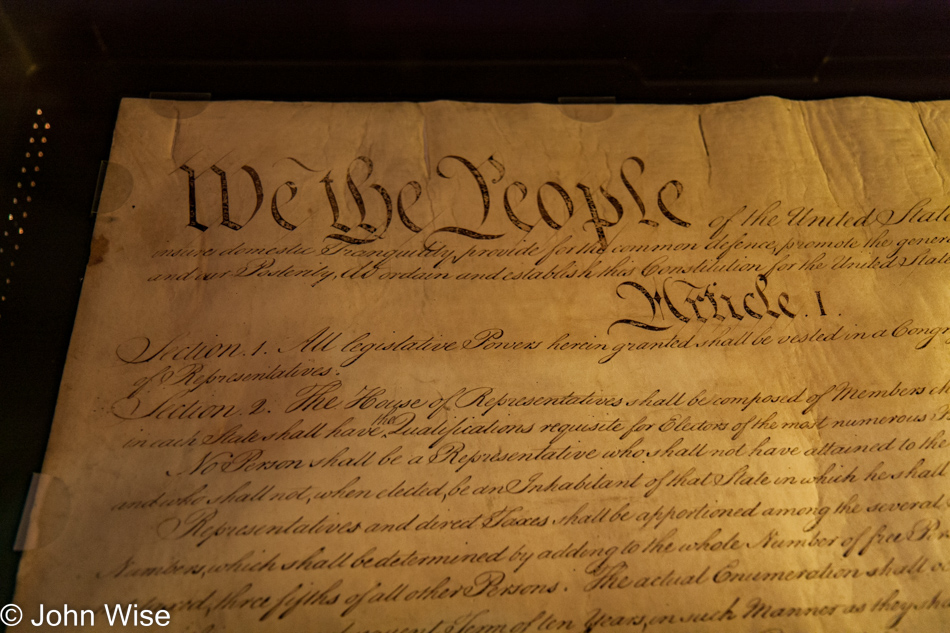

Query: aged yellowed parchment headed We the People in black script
[16,98,950,633]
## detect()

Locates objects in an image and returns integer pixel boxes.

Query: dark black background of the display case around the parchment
[0,0,950,603]
